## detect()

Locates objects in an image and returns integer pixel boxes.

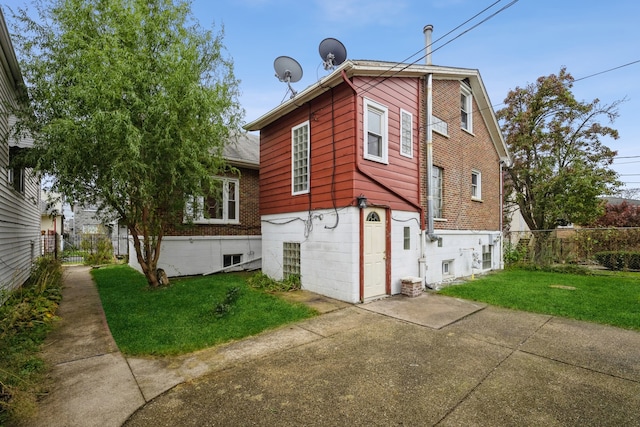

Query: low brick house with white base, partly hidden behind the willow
[129,134,261,276]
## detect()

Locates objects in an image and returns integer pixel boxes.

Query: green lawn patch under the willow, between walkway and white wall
[92,266,316,355]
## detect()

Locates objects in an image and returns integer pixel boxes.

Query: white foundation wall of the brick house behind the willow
[129,236,262,277]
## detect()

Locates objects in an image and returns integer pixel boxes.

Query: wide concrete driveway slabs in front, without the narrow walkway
[125,294,640,426]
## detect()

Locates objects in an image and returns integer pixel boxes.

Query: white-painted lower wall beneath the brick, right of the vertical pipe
[425,230,502,288]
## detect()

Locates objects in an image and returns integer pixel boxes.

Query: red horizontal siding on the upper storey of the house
[260,78,421,215]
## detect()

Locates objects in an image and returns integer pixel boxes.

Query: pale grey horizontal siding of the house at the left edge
[0,17,40,290]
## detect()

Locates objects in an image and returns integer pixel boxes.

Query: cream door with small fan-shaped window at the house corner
[363,208,387,299]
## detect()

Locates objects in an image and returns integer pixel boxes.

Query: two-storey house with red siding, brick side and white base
[245,48,509,302]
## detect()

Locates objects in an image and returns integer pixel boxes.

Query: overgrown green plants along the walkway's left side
[0,258,62,426]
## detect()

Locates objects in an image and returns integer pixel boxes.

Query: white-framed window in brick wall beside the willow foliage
[185,178,240,224]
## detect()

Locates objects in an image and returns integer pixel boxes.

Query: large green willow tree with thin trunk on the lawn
[13,0,242,286]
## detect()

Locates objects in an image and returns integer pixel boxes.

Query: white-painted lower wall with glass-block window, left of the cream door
[262,207,360,302]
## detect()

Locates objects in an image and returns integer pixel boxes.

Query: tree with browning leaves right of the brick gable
[497,68,621,234]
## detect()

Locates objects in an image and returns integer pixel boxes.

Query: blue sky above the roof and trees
[2,0,640,192]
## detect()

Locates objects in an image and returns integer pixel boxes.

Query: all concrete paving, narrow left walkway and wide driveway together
[22,267,640,427]
